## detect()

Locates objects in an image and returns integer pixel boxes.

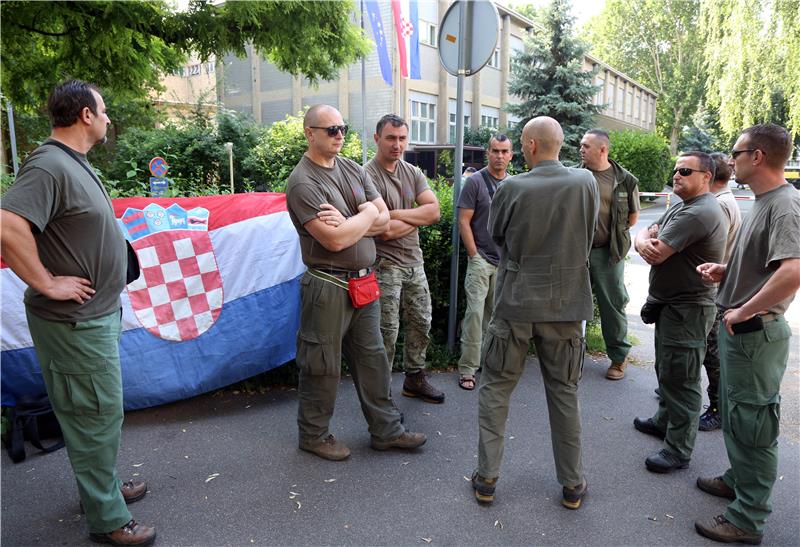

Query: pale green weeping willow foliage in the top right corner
[700,0,800,136]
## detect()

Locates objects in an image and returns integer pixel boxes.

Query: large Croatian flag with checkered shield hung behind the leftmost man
[0,193,305,410]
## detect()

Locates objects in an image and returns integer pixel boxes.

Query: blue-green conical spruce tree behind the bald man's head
[506,0,600,167]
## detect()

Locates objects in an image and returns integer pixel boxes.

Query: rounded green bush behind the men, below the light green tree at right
[609,130,673,192]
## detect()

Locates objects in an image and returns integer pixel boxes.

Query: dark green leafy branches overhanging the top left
[0,0,368,110]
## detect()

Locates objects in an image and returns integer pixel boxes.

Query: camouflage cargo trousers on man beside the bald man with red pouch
[375,258,431,373]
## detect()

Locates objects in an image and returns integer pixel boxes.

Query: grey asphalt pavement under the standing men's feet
[2,346,800,547]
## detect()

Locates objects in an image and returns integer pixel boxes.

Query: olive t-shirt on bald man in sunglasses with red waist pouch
[286,156,380,271]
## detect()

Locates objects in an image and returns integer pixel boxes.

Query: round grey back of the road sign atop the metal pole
[438,0,500,76]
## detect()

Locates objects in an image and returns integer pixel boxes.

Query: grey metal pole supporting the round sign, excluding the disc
[447,2,472,353]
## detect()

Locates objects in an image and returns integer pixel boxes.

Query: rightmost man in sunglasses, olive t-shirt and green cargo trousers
[695,124,800,544]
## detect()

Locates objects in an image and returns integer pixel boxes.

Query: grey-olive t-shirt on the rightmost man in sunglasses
[717,184,800,314]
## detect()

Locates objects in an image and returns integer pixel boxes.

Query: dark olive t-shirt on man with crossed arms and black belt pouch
[648,192,728,305]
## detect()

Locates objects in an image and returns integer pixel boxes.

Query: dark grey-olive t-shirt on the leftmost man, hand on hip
[2,139,128,322]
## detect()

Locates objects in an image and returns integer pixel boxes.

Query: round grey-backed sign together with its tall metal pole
[438,0,500,352]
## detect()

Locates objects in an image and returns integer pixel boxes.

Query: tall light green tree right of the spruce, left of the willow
[587,0,706,154]
